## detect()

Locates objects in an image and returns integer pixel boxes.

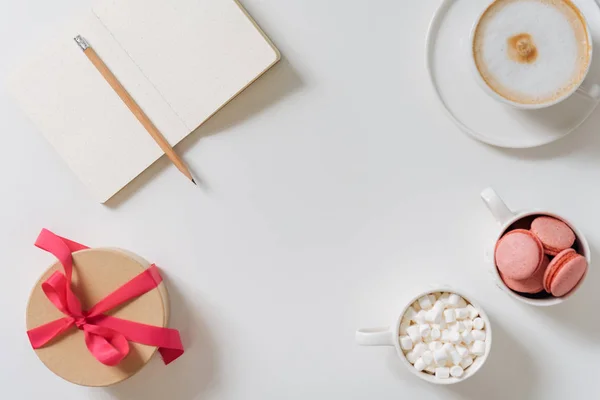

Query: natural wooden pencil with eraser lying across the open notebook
[75,35,196,184]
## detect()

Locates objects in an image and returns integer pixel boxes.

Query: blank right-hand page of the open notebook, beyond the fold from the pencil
[93,0,279,131]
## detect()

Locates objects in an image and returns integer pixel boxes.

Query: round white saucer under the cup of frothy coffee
[427,0,600,148]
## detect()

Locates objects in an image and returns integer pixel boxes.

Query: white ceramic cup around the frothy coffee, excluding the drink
[469,0,600,110]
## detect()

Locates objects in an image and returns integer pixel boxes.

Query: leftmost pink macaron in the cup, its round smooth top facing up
[494,229,544,280]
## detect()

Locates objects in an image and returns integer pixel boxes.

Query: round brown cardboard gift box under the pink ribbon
[27,248,169,386]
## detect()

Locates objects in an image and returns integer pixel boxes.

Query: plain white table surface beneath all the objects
[0,0,600,400]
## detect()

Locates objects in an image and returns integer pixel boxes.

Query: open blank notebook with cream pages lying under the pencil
[10,0,279,202]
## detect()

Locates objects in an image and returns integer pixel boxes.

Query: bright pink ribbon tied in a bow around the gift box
[27,229,183,366]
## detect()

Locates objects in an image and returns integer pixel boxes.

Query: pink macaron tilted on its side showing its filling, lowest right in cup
[544,249,588,297]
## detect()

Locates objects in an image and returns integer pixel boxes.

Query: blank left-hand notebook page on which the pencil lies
[9,13,189,202]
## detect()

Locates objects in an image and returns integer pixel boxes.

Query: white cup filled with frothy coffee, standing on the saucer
[470,0,600,109]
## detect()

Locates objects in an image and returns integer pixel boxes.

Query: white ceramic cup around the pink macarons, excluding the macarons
[481,188,591,306]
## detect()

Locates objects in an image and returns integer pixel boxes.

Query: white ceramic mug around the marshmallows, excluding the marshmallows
[356,286,492,385]
